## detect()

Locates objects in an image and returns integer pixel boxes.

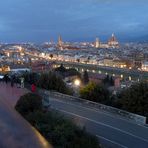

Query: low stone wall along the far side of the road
[38,89,146,124]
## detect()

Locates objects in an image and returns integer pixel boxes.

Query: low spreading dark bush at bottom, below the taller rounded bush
[27,111,99,148]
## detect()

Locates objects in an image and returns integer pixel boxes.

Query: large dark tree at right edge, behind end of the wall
[117,82,148,117]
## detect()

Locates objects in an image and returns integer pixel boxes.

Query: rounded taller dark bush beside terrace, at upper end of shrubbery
[15,93,42,116]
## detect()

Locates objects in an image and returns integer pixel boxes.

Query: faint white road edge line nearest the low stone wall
[50,98,148,129]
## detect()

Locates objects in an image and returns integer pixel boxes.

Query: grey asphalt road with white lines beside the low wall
[50,98,148,148]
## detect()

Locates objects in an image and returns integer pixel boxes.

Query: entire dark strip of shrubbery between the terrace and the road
[15,93,100,148]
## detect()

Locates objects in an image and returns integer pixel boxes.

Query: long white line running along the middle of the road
[53,108,148,143]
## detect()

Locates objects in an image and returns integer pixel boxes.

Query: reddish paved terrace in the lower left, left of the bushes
[0,82,51,148]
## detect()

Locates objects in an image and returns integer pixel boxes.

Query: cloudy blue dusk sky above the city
[0,0,148,43]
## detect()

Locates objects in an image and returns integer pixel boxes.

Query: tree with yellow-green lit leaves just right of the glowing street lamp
[80,82,110,104]
